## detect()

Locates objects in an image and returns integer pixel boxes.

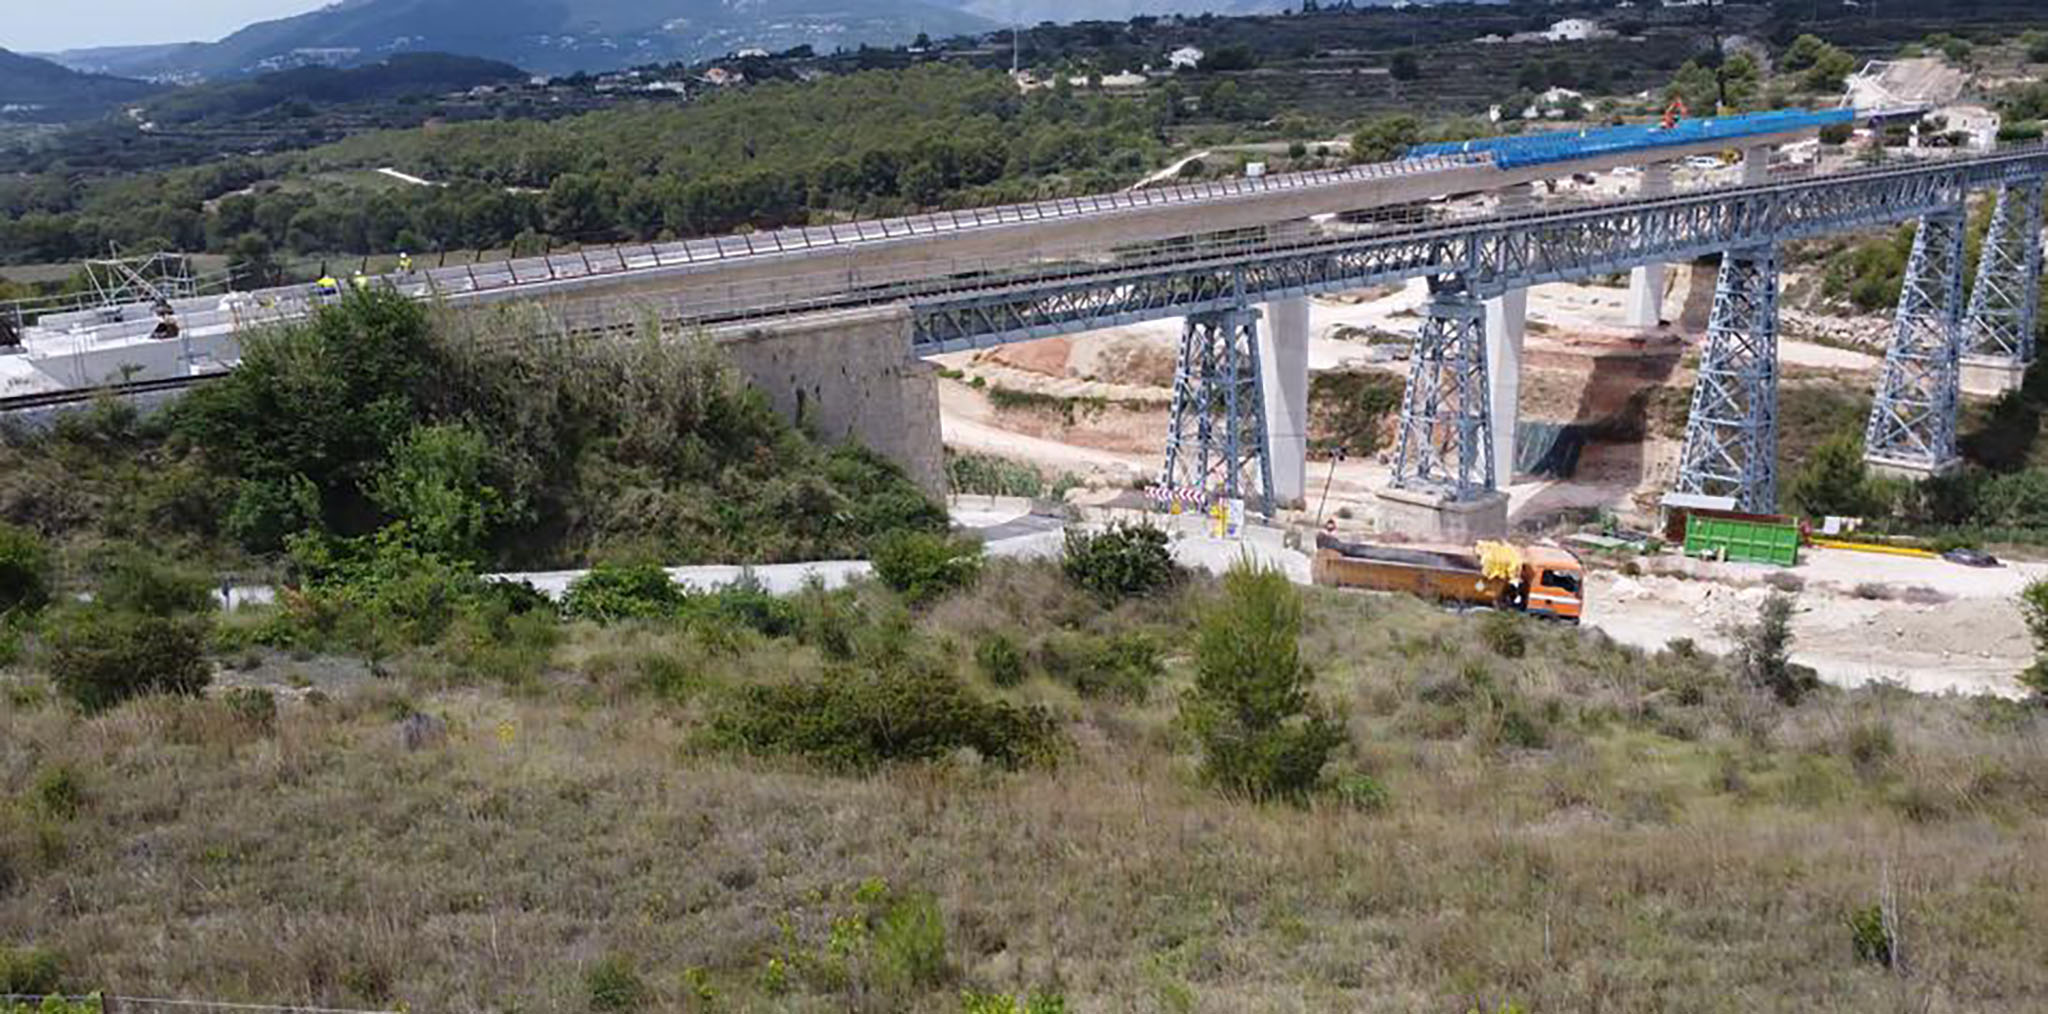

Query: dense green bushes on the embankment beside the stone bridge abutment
[0,295,944,574]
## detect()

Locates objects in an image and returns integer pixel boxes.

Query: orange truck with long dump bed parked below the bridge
[1311,535,1585,623]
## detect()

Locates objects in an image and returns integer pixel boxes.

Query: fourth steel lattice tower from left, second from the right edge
[1864,205,1966,475]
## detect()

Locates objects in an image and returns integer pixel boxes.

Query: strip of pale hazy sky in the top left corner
[0,0,330,53]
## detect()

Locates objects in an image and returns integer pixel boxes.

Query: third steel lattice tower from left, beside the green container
[1675,246,1778,514]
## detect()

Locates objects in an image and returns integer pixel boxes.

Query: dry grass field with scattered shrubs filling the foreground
[0,563,2048,1014]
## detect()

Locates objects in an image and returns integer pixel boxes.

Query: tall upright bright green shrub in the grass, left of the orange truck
[1182,563,1343,799]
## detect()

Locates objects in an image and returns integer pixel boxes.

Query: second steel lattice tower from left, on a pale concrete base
[1393,279,1495,502]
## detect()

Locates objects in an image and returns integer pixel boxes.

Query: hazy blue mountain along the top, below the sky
[49,0,991,80]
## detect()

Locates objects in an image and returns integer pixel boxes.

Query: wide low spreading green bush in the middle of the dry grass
[713,666,1057,770]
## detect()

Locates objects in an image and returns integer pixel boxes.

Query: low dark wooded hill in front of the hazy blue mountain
[143,53,526,123]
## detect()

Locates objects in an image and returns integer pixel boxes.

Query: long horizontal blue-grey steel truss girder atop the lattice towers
[905,150,2048,354]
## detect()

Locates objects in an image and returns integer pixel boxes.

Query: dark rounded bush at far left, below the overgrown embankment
[47,606,213,711]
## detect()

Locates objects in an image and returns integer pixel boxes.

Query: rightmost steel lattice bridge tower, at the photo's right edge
[1964,178,2042,367]
